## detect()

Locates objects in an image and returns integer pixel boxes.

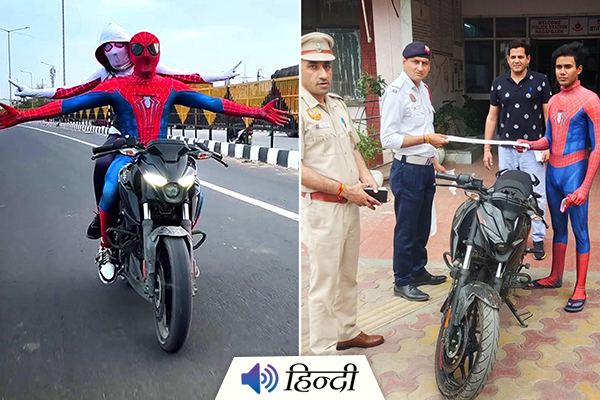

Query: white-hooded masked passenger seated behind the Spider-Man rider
[9,22,238,239]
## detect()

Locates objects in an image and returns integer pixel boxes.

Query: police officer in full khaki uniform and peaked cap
[300,32,383,354]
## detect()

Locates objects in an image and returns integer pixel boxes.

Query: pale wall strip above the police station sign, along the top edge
[462,0,600,17]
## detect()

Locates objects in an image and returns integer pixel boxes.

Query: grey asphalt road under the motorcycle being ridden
[0,125,299,400]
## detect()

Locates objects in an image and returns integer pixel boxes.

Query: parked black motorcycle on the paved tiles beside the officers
[435,170,547,400]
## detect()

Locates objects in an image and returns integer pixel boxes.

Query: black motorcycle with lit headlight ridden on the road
[92,138,227,353]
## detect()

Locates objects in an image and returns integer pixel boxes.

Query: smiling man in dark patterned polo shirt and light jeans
[483,40,552,260]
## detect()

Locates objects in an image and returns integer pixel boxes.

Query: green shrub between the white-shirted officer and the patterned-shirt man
[433,94,481,136]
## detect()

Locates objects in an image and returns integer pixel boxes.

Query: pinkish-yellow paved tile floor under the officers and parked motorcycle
[302,155,600,400]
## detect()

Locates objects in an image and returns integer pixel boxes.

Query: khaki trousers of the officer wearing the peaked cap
[301,196,360,354]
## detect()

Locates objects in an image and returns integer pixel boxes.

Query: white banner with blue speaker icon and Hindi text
[216,355,384,400]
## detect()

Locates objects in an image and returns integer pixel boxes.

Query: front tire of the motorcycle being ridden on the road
[154,237,192,353]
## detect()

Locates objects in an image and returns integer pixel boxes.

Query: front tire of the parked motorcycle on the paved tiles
[435,299,500,400]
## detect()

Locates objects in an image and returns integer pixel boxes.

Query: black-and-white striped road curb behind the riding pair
[36,122,300,169]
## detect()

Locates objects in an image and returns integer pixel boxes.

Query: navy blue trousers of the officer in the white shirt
[390,158,435,286]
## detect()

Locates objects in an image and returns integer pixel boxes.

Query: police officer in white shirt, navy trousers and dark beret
[381,42,448,301]
